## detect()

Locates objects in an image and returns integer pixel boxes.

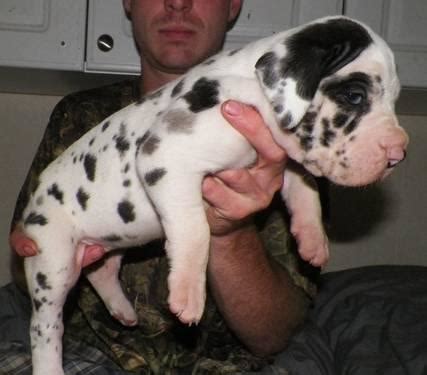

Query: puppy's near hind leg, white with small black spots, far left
[25,226,82,375]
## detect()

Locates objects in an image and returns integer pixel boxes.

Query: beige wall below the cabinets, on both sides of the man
[0,89,427,285]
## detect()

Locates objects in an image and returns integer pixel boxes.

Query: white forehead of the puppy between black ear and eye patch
[337,32,400,103]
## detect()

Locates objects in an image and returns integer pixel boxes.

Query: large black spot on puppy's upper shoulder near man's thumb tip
[183,77,219,113]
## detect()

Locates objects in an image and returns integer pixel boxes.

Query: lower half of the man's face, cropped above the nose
[123,0,241,74]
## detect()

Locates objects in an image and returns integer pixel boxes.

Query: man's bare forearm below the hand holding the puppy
[208,226,308,355]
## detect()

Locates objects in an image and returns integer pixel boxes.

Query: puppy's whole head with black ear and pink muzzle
[256,17,408,185]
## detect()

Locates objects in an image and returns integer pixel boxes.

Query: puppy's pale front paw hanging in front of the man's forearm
[168,276,206,325]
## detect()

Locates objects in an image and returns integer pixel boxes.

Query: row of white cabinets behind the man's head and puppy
[0,0,427,88]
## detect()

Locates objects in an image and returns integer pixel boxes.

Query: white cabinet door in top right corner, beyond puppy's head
[345,0,427,87]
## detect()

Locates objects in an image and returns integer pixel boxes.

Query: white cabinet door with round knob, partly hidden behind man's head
[86,0,342,73]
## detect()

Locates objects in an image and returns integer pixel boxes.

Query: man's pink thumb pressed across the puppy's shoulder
[222,100,286,162]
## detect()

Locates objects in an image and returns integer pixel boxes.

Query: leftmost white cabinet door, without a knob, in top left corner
[0,0,86,70]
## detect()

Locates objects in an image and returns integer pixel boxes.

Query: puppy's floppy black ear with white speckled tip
[255,17,372,129]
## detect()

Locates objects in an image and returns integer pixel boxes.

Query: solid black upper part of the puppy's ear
[280,18,372,100]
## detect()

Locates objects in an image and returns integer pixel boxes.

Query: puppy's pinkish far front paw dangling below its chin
[291,223,329,267]
